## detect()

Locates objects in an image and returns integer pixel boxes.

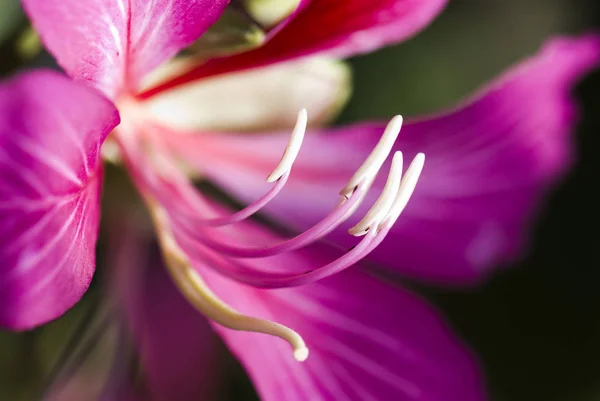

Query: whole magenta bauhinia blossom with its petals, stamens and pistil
[0,0,600,401]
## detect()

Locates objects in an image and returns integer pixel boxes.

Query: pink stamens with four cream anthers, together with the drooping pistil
[115,108,425,361]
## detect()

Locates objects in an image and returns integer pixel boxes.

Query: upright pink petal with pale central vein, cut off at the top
[23,0,229,97]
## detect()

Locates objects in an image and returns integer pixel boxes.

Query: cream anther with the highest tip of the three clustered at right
[340,116,402,197]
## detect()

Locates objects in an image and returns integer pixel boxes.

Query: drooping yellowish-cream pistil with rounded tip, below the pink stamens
[148,201,308,362]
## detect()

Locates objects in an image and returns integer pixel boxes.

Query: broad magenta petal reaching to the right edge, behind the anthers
[163,36,600,283]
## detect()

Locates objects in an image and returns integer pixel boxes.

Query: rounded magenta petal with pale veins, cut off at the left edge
[0,71,119,329]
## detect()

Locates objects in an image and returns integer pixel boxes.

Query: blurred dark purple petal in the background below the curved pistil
[130,266,223,401]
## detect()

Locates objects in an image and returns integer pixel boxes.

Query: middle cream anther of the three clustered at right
[348,152,402,237]
